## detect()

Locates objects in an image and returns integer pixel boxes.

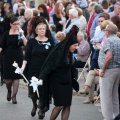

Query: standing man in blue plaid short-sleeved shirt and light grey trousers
[98,24,120,120]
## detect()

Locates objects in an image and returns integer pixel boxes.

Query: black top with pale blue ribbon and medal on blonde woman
[25,38,52,80]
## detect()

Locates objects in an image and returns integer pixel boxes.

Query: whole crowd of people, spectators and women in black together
[0,0,120,120]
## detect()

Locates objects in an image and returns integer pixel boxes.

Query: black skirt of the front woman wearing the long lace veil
[51,83,72,106]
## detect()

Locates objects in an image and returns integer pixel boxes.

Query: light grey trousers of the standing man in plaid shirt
[99,68,120,120]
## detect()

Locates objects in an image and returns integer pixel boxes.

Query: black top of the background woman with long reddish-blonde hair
[53,14,63,32]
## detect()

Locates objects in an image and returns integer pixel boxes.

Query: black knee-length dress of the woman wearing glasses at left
[0,31,23,79]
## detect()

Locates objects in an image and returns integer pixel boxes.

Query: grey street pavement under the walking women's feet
[0,77,103,120]
